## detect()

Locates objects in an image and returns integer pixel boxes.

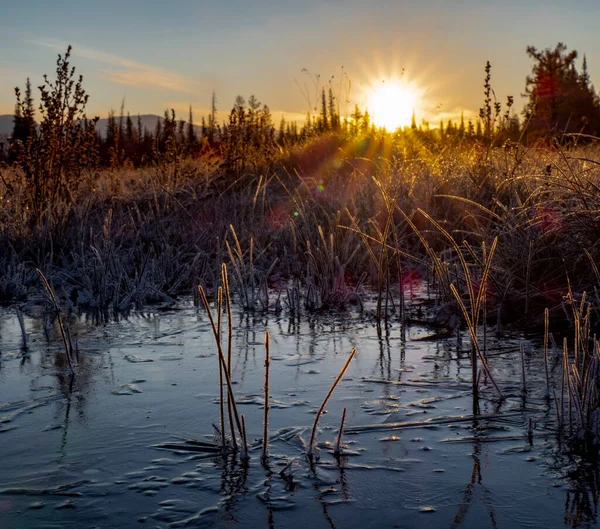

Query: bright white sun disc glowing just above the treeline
[367,81,416,132]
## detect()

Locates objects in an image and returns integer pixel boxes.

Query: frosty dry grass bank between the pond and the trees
[0,134,600,330]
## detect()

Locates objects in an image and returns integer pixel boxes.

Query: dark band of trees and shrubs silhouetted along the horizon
[0,43,600,174]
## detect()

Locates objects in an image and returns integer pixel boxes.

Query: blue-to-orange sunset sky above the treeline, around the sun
[0,0,600,124]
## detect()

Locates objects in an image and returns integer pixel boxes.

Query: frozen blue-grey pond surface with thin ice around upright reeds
[0,296,598,529]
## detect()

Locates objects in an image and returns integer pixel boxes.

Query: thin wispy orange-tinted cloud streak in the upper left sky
[29,39,199,93]
